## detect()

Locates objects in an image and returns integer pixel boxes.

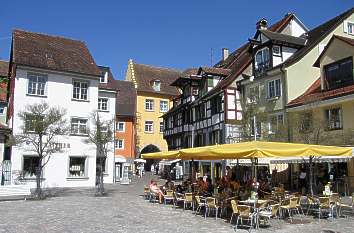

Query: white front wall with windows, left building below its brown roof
[9,67,116,187]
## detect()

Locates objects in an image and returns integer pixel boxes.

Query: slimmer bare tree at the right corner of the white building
[85,112,114,196]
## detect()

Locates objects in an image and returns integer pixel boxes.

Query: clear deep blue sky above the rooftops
[0,0,354,79]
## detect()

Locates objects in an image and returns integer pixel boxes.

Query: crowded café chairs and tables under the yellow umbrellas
[144,179,354,229]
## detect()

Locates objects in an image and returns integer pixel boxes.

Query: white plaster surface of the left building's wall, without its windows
[12,68,115,187]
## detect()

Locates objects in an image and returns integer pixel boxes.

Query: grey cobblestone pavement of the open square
[0,172,354,233]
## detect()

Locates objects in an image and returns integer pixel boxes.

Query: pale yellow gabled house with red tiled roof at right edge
[287,35,354,194]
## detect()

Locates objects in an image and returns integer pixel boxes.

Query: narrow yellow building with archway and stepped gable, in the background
[125,60,181,157]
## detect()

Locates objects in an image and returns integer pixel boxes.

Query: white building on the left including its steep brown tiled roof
[8,30,116,187]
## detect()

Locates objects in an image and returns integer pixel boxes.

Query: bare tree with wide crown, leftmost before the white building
[13,102,69,199]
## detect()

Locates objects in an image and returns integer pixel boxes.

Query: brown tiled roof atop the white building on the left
[12,30,101,76]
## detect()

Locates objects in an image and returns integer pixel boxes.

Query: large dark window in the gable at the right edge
[324,57,354,89]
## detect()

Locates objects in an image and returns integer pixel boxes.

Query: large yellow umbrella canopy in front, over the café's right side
[179,141,353,160]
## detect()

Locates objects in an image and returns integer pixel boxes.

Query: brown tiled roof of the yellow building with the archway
[132,63,182,96]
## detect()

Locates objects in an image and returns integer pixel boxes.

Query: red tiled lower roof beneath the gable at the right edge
[287,78,354,108]
